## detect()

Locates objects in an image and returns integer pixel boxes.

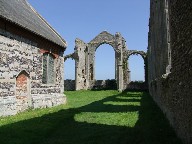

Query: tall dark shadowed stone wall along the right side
[148,0,192,144]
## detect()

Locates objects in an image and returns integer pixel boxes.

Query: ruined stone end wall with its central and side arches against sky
[65,31,147,91]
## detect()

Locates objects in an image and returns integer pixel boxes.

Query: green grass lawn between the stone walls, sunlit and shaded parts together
[0,90,181,144]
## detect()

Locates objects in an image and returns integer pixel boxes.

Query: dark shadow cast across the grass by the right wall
[0,92,181,144]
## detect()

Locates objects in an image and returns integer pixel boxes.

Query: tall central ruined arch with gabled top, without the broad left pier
[86,31,126,91]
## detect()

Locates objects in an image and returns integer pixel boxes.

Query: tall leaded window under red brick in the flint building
[42,53,55,84]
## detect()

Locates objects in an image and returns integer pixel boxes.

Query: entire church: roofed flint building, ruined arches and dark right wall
[0,0,192,144]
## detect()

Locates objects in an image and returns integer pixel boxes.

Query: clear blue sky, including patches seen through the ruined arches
[28,0,149,80]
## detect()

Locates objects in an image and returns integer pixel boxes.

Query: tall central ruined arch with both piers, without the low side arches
[72,31,126,91]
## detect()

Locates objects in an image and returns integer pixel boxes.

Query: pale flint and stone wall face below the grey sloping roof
[0,29,66,116]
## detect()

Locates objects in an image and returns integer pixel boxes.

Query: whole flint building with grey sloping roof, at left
[0,0,66,116]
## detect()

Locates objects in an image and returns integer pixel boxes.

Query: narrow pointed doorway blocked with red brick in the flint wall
[15,70,32,111]
